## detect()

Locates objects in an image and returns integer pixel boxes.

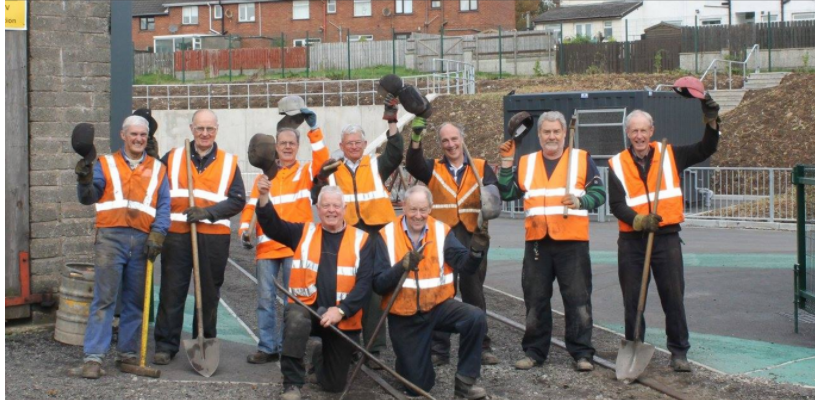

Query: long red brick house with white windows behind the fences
[132,0,515,52]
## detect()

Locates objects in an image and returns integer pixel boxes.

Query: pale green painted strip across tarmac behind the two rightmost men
[489,247,795,270]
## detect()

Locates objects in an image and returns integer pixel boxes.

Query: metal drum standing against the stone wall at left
[54,263,94,346]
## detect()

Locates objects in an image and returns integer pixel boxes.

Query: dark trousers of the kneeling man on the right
[388,299,487,395]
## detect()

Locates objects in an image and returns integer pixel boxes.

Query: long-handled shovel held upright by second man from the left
[183,139,221,378]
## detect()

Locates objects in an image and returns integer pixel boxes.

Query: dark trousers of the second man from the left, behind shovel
[154,233,229,355]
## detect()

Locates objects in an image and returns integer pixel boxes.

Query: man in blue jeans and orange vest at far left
[75,115,170,379]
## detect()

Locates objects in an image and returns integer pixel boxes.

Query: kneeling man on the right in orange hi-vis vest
[373,185,489,399]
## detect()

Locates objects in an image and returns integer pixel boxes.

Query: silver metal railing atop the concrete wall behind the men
[133,59,475,110]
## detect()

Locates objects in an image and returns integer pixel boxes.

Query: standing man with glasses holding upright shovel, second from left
[153,110,246,365]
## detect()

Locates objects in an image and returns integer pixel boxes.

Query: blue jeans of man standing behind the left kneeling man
[256,257,292,354]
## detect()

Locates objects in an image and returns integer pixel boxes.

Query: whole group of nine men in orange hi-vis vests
[76,85,718,400]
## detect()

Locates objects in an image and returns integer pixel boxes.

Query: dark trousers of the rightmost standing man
[617,233,690,357]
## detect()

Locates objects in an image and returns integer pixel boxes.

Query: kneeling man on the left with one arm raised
[256,185,385,400]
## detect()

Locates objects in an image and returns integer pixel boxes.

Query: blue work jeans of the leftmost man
[84,228,147,362]
